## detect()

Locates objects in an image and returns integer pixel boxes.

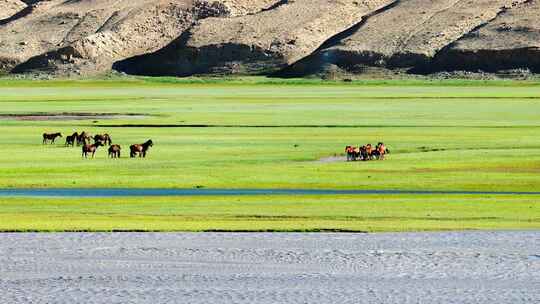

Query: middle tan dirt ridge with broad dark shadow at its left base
[114,0,392,75]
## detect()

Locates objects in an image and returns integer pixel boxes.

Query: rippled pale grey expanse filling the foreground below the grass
[0,231,540,304]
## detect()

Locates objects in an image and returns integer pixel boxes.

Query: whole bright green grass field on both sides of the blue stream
[0,78,540,231]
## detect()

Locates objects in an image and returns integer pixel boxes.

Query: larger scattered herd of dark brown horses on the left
[43,131,154,158]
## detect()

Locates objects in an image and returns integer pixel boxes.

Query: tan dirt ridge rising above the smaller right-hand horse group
[314,0,525,67]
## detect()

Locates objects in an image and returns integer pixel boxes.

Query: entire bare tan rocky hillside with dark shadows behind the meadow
[0,0,540,77]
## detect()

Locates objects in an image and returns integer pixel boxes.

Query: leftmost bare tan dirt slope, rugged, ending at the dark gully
[0,0,282,75]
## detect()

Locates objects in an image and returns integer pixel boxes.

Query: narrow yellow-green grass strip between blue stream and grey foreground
[0,195,540,232]
